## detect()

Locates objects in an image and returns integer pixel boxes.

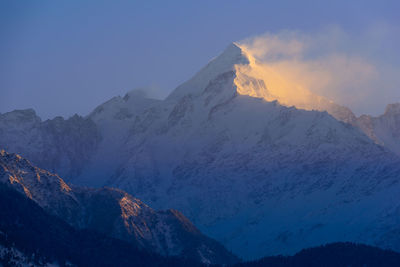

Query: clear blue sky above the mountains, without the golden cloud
[0,0,400,118]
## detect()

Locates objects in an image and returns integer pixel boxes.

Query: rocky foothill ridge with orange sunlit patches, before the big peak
[0,151,237,263]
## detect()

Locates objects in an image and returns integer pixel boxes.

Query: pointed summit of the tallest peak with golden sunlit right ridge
[168,43,356,123]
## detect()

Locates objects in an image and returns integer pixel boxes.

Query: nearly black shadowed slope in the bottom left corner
[0,183,203,267]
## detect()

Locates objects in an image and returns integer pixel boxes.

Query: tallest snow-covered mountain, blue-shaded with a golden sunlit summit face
[0,44,400,259]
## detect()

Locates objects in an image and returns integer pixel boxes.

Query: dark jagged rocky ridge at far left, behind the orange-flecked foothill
[0,109,101,180]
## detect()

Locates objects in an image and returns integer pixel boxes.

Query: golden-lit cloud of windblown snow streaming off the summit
[240,23,400,115]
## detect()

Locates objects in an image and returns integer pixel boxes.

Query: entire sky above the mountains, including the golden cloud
[0,0,400,119]
